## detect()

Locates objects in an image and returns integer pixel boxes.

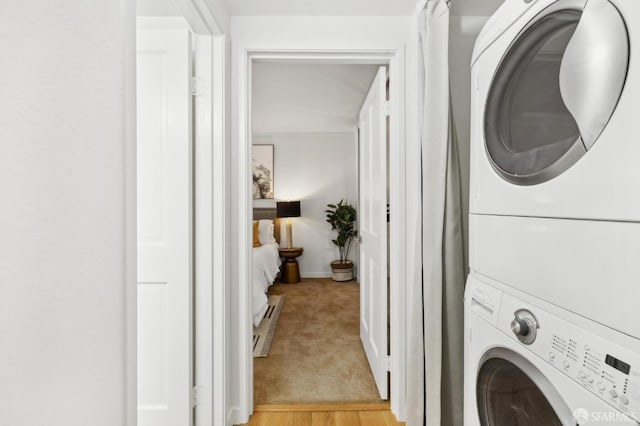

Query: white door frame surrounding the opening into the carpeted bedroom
[232,51,405,423]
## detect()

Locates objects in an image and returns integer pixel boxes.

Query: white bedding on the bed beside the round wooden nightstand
[253,243,280,327]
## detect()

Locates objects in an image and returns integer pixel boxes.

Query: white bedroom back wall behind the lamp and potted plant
[253,132,358,277]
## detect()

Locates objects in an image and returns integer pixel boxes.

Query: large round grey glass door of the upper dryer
[484,0,629,185]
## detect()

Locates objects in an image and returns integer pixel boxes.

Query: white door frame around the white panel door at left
[134,0,230,426]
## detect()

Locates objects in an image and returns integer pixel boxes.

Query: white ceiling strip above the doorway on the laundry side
[227,0,416,16]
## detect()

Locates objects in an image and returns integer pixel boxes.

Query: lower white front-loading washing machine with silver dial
[464,275,640,426]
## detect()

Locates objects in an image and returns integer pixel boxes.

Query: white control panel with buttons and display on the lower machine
[498,295,640,423]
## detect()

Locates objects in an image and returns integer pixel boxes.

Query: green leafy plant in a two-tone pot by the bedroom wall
[325,200,358,281]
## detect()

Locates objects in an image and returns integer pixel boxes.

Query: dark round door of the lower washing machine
[476,349,576,426]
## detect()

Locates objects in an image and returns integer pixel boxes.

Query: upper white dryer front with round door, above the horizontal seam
[470,0,640,222]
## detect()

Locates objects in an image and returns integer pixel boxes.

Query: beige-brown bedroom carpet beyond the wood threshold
[254,279,380,404]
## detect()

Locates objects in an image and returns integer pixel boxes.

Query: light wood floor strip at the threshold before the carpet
[238,403,404,426]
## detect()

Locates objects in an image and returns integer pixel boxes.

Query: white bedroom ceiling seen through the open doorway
[251,62,379,134]
